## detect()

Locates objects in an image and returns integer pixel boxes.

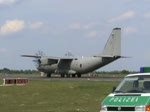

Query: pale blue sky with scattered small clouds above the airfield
[0,0,150,71]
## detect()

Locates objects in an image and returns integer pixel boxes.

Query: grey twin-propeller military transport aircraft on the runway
[21,28,121,77]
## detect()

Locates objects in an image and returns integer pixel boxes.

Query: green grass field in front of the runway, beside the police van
[0,80,119,112]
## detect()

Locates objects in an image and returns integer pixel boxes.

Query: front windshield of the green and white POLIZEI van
[114,75,150,93]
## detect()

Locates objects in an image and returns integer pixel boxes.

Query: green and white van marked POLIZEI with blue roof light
[100,73,150,112]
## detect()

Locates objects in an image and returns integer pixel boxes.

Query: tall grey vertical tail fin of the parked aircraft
[103,28,121,56]
